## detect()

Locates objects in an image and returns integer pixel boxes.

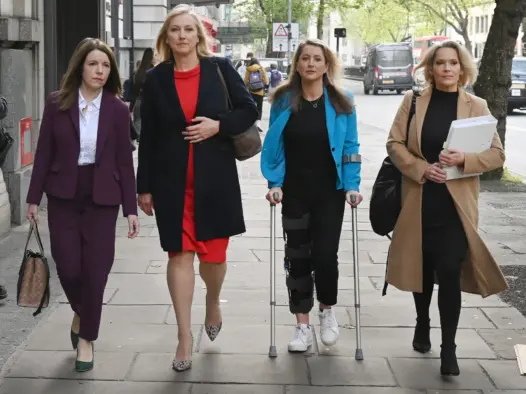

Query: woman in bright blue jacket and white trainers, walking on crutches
[261,40,362,352]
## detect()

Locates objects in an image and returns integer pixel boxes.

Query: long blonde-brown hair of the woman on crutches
[270,39,354,114]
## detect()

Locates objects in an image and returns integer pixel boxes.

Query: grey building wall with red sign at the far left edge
[0,0,45,237]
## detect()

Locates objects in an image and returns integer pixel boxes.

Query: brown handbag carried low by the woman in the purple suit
[17,223,50,316]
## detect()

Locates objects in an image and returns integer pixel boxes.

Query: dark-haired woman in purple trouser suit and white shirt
[27,39,139,372]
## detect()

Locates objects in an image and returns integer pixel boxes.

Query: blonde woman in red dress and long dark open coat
[137,4,257,371]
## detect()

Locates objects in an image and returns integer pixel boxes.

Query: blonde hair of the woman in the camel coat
[414,41,478,88]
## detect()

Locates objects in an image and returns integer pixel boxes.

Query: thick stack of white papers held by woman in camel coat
[443,115,497,180]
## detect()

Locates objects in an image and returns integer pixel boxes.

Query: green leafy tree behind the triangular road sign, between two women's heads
[234,0,315,57]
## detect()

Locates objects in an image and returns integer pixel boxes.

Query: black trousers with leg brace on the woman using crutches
[282,189,345,314]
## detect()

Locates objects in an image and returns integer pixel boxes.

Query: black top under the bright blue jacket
[283,95,337,193]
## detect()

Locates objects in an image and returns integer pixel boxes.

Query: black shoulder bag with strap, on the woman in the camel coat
[369,90,418,239]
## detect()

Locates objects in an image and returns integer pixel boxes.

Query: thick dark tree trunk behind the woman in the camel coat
[474,0,526,179]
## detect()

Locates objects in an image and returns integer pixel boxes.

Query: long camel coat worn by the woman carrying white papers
[386,88,508,297]
